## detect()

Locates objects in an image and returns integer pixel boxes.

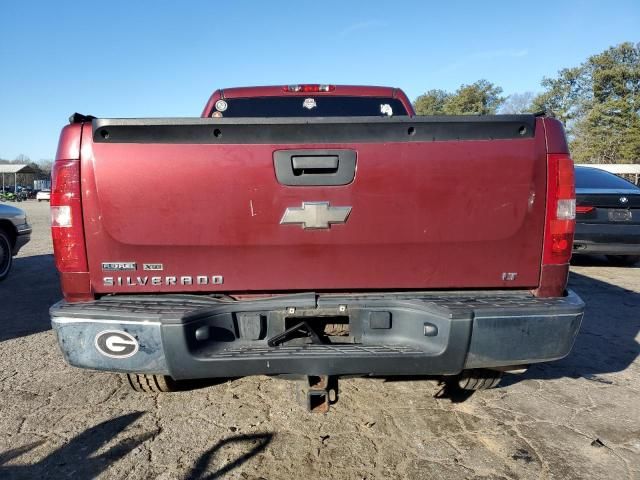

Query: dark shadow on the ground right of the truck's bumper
[501,272,640,386]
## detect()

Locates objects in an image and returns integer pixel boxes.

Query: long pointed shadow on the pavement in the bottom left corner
[0,412,158,479]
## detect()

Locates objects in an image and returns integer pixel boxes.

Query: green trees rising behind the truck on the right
[414,42,640,163]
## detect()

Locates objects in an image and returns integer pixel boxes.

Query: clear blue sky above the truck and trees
[0,0,640,160]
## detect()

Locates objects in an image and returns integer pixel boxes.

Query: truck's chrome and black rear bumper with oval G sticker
[51,292,584,379]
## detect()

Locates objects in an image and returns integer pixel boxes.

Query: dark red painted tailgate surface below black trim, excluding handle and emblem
[82,126,546,292]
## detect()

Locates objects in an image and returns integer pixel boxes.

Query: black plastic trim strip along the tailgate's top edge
[93,115,535,144]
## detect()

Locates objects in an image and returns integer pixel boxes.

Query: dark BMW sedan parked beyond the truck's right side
[573,167,640,265]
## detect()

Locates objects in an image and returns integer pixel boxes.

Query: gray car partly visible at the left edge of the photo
[0,204,31,282]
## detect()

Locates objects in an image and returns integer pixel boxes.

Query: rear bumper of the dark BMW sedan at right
[573,223,640,255]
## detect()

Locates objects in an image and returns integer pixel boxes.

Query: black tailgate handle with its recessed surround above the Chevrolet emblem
[273,149,356,187]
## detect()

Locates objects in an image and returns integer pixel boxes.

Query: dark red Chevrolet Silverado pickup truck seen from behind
[51,85,584,401]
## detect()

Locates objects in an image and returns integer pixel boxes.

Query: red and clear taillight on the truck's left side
[50,160,87,273]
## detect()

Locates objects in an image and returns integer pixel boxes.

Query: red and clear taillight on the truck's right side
[542,154,576,265]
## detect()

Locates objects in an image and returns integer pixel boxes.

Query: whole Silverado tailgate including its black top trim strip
[81,116,546,293]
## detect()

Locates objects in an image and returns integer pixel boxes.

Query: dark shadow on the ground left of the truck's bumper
[0,255,62,342]
